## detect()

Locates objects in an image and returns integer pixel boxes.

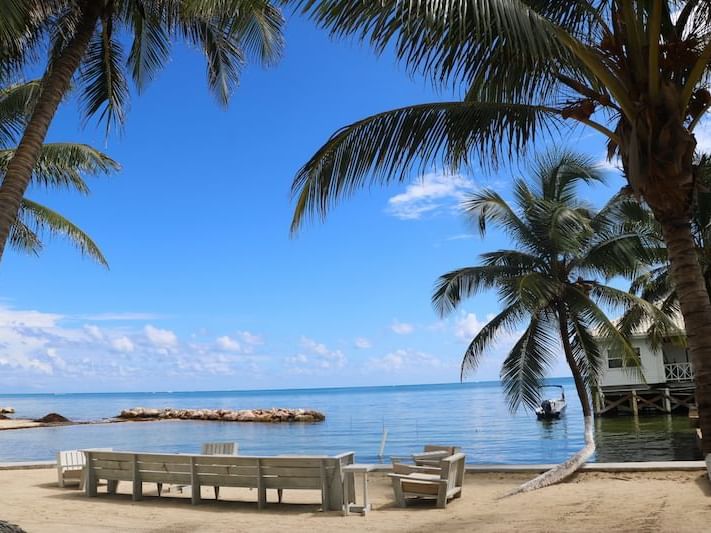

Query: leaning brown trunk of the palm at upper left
[0,0,103,259]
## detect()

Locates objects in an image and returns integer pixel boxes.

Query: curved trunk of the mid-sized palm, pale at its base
[506,304,595,496]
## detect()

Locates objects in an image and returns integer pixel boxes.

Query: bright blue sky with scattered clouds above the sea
[0,11,636,392]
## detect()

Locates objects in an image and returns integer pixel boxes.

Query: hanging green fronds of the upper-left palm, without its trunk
[8,0,284,133]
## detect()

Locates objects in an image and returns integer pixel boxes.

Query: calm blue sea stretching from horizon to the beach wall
[0,379,700,463]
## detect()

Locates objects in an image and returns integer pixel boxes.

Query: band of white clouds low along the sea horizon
[0,305,572,392]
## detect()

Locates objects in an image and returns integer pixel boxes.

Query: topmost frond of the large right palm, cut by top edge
[297,0,594,89]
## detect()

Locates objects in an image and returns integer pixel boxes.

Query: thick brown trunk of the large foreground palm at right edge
[659,219,711,455]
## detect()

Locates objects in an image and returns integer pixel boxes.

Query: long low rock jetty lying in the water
[118,407,326,422]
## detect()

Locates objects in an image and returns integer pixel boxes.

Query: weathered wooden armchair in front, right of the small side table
[388,453,466,508]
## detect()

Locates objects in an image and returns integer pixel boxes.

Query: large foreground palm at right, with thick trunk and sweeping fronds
[292,0,711,453]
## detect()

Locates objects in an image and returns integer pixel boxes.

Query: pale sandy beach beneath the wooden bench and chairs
[0,470,711,533]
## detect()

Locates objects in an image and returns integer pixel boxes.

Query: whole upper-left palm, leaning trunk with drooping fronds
[0,0,283,257]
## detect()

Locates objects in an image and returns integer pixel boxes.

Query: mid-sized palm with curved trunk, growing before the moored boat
[432,153,668,490]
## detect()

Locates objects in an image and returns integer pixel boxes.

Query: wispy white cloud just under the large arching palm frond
[386,173,476,220]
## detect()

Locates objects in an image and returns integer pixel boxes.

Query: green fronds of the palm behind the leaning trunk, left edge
[0,81,119,267]
